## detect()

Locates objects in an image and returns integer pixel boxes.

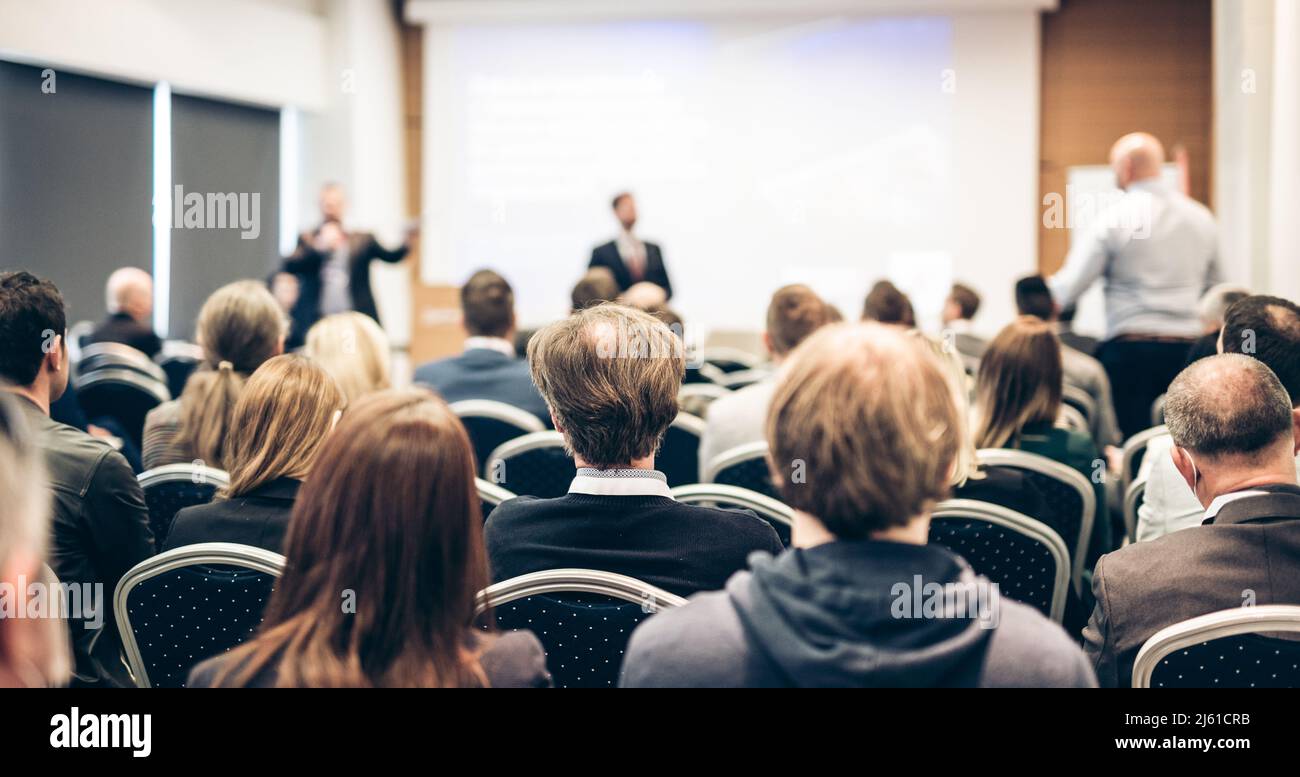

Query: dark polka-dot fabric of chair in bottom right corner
[1151,634,1300,689]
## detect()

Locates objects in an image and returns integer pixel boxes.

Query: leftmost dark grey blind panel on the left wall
[0,62,153,324]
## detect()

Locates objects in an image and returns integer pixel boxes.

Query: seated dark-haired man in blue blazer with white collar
[415,270,550,421]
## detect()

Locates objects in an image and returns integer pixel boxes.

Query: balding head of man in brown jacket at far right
[1165,353,1292,457]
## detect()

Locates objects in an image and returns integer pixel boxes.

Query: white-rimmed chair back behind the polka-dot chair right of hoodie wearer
[976,448,1097,594]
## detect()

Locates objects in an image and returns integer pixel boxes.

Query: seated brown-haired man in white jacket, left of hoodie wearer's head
[699,285,831,479]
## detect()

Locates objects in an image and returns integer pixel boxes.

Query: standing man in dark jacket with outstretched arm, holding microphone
[281,183,415,344]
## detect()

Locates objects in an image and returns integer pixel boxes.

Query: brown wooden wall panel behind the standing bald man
[1039,0,1214,273]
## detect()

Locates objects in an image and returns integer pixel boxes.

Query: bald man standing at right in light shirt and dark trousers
[1048,133,1222,438]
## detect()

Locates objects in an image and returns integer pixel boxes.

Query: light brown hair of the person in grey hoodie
[767,324,962,539]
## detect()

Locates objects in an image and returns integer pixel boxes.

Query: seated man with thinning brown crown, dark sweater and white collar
[486,305,781,595]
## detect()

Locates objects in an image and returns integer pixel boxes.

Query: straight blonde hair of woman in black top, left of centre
[225,355,345,496]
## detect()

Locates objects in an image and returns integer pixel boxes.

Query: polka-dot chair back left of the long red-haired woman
[113,542,285,687]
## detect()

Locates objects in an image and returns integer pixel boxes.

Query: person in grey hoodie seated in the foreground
[621,324,1097,687]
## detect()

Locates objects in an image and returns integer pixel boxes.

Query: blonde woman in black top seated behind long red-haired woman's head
[163,356,345,554]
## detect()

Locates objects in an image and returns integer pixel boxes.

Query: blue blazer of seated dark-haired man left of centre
[415,348,551,426]
